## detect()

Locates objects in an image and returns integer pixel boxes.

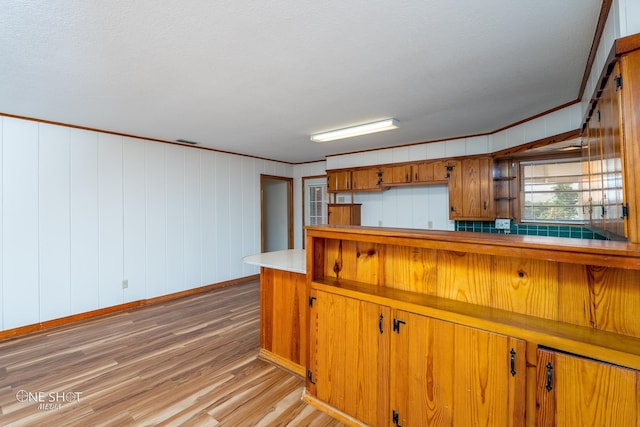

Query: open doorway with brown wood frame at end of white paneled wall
[260,175,293,252]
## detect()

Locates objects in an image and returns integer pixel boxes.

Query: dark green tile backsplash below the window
[455,221,607,240]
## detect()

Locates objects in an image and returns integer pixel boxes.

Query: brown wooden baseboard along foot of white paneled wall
[0,274,260,340]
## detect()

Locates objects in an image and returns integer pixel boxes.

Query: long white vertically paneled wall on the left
[0,117,293,330]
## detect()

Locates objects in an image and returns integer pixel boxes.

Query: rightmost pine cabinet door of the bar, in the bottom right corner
[536,349,640,427]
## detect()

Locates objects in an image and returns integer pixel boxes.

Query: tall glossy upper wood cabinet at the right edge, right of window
[583,34,640,243]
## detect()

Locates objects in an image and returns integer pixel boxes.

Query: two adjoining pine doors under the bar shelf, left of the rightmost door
[307,290,526,427]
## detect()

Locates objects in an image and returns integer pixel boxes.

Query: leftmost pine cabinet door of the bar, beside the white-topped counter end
[307,291,391,426]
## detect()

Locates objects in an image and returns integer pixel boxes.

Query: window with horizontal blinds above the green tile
[520,158,589,224]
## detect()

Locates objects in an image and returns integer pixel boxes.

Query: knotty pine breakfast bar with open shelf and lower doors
[303,226,640,427]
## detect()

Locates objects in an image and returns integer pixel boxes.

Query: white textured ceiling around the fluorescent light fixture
[0,0,601,162]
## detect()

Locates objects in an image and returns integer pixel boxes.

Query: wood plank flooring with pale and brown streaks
[0,281,343,427]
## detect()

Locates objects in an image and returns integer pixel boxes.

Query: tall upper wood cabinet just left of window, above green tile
[449,157,494,220]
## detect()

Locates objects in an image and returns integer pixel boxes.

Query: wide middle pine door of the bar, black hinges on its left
[390,311,526,427]
